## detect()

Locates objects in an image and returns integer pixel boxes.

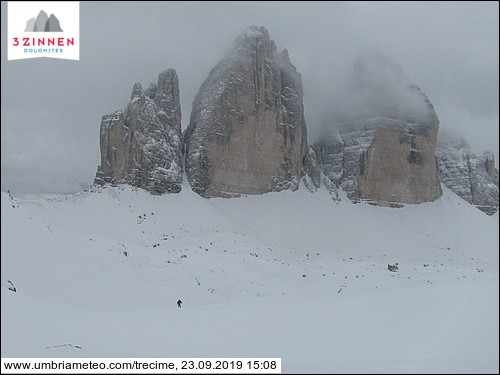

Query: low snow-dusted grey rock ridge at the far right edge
[436,132,499,215]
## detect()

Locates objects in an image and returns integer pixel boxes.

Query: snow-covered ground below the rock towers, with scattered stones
[1,186,499,373]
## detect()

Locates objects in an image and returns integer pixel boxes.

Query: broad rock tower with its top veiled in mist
[314,56,442,206]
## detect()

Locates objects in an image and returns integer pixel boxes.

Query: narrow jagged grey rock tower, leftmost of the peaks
[94,69,182,194]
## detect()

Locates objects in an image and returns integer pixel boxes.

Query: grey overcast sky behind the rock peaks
[1,1,499,195]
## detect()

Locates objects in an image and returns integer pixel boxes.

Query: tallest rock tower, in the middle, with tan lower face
[184,27,307,197]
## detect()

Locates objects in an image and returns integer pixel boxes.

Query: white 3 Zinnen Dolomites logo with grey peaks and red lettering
[7,2,80,60]
